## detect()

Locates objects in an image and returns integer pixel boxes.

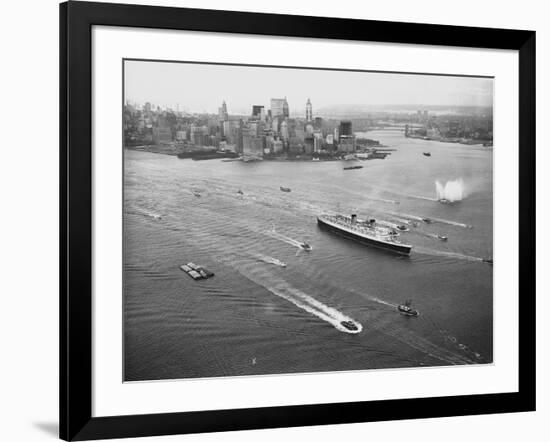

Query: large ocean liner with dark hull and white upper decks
[317,214,412,255]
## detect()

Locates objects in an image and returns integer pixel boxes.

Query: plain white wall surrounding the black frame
[0,0,550,442]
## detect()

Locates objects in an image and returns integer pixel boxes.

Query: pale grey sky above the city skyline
[124,60,493,115]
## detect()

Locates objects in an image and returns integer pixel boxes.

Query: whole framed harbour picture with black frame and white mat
[60,2,535,440]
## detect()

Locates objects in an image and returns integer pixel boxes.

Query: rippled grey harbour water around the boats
[124,131,493,381]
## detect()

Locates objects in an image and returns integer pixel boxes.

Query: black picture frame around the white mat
[59,2,535,440]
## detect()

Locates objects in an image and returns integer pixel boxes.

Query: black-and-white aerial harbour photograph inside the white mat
[123,59,493,381]
